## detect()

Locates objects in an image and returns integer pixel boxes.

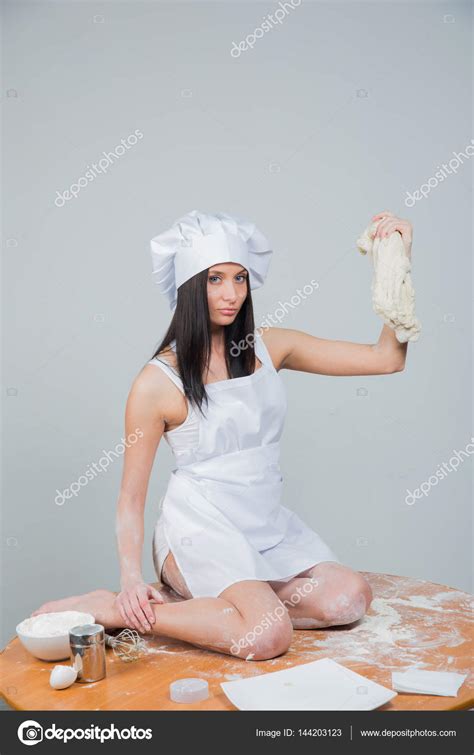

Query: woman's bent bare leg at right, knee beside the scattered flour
[269,561,373,629]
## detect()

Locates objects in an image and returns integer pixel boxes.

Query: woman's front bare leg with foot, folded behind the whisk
[31,580,293,660]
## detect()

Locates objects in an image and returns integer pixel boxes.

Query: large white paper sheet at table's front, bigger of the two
[221,658,397,710]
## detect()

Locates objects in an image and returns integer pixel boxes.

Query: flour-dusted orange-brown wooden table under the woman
[0,572,474,710]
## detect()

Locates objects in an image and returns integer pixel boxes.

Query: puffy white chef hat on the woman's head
[150,210,273,310]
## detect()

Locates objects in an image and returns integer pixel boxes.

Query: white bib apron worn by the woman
[150,333,341,598]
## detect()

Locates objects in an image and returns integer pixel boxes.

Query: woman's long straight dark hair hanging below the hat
[152,269,255,413]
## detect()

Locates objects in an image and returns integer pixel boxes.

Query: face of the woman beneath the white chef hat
[207,262,248,325]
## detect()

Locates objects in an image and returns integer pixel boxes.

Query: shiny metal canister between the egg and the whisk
[69,624,106,683]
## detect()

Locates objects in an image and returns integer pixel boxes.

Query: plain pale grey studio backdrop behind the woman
[1,0,472,668]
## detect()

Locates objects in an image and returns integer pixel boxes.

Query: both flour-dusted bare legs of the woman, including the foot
[27,561,372,660]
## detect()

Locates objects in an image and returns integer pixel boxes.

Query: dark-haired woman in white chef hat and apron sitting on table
[31,211,412,660]
